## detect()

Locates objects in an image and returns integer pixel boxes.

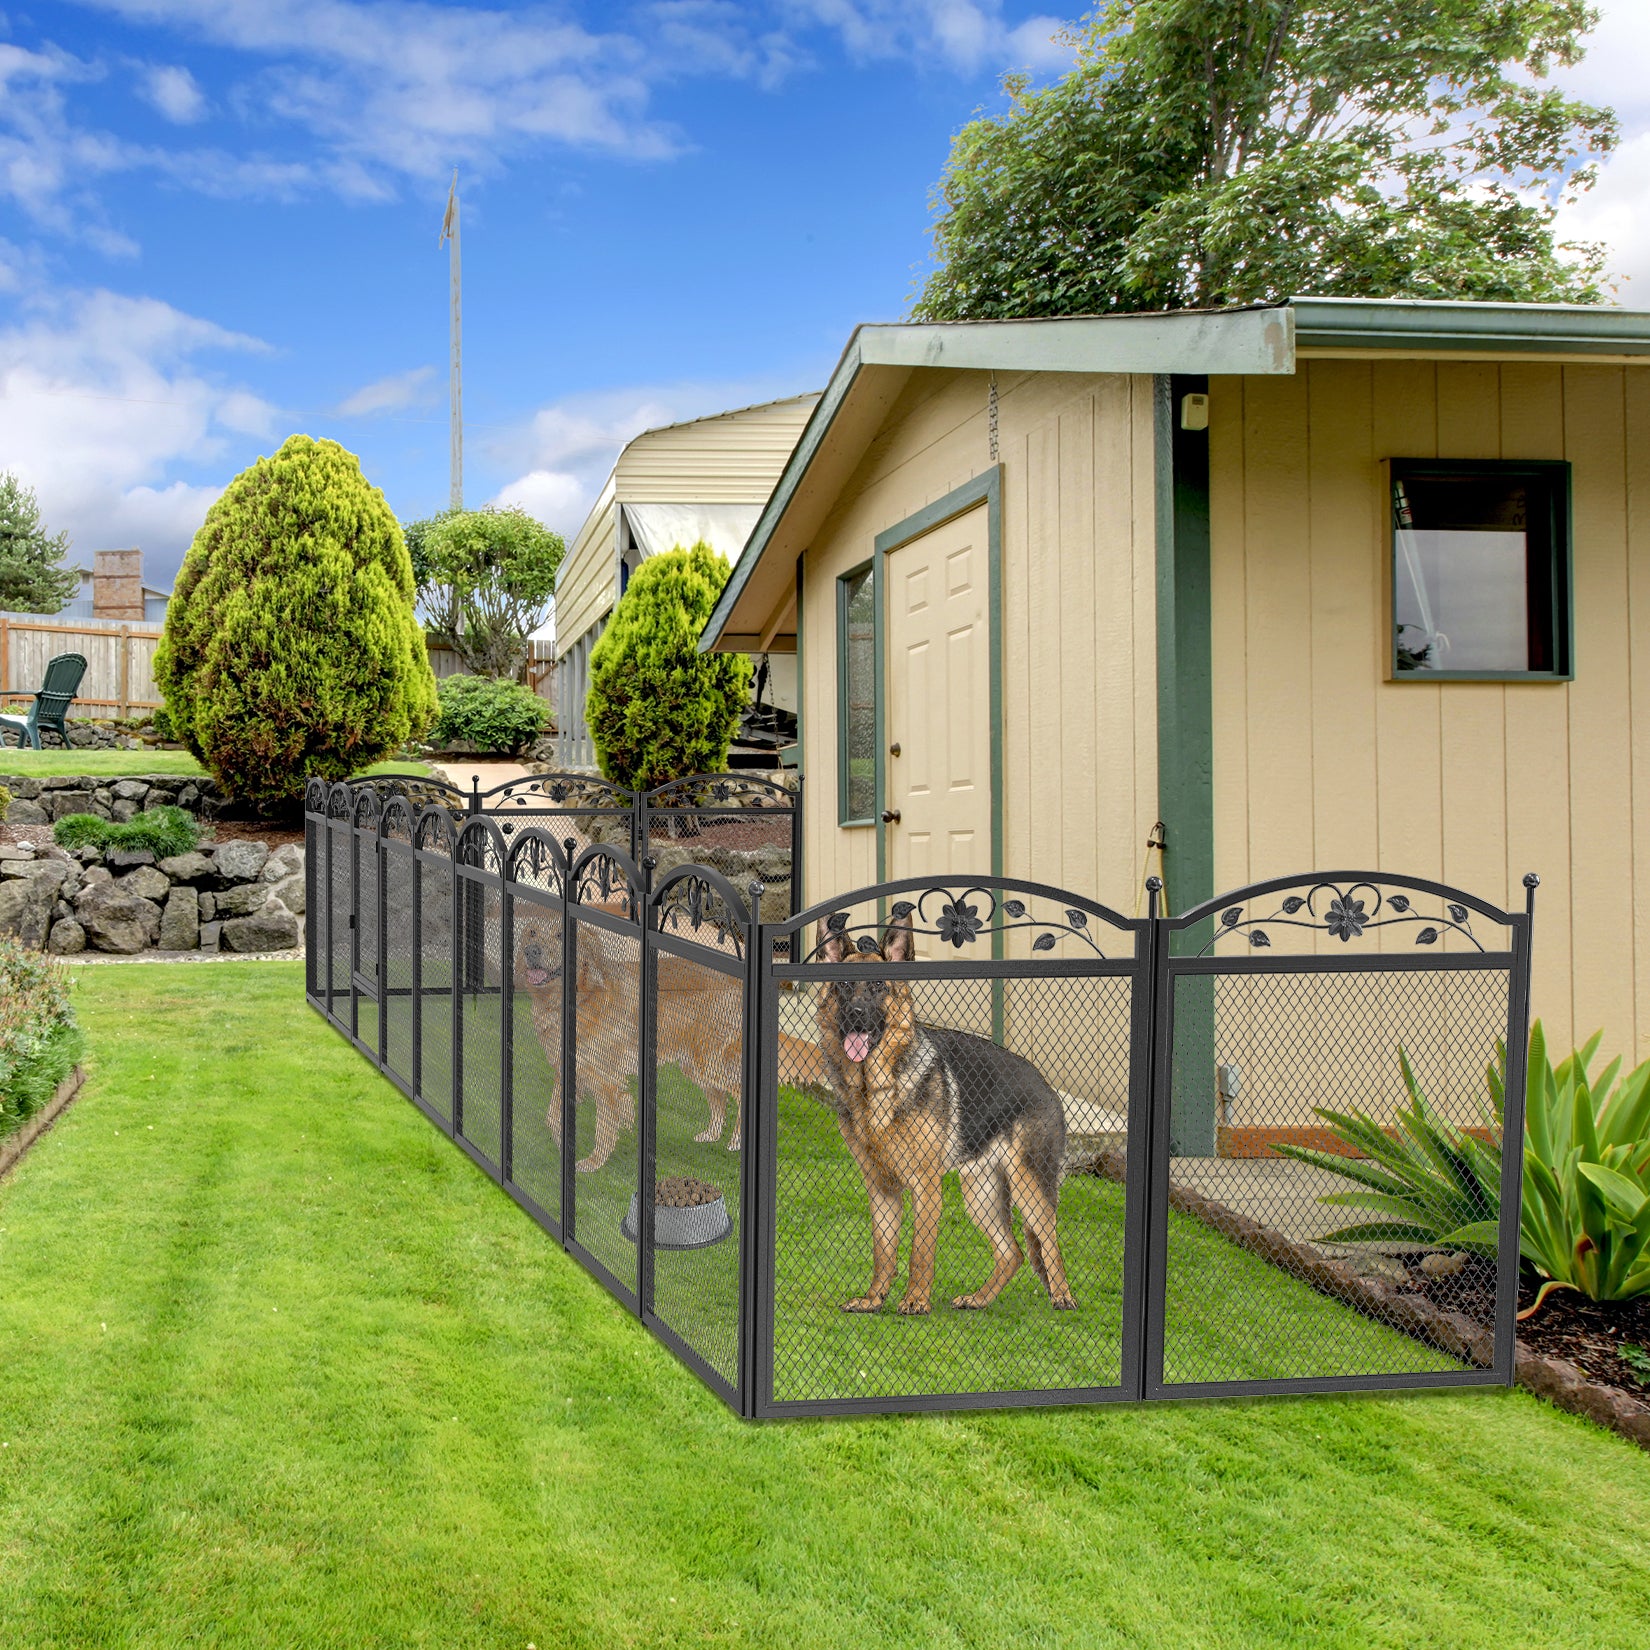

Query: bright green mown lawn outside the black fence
[0,964,1650,1650]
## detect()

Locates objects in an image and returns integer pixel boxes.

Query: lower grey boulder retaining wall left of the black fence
[0,842,304,957]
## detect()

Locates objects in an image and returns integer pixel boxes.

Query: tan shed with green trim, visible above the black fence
[705,299,1650,1059]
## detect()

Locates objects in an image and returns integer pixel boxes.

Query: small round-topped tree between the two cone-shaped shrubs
[414,505,566,677]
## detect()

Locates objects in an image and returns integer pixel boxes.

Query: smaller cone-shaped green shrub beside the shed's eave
[584,540,751,790]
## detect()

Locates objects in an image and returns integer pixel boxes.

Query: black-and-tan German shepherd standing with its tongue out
[815,917,1076,1313]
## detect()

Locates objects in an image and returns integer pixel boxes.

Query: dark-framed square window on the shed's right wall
[1393,459,1571,680]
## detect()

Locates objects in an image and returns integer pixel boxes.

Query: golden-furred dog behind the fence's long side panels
[515,901,743,1175]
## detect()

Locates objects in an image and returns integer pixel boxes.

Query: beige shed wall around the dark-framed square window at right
[1207,360,1650,1059]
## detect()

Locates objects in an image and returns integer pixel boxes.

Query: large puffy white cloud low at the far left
[0,289,276,582]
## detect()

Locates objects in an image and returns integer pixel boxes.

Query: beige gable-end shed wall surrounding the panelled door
[802,371,1157,916]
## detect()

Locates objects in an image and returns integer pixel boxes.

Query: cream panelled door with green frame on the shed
[884,505,992,897]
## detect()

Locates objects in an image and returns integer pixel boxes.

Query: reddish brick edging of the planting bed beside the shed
[1071,1148,1650,1450]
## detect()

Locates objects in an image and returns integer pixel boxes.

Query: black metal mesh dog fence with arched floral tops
[305,776,1533,1416]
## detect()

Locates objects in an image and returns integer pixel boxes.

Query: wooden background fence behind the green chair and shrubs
[0,614,554,716]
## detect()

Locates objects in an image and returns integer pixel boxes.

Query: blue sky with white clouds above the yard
[0,0,1650,584]
